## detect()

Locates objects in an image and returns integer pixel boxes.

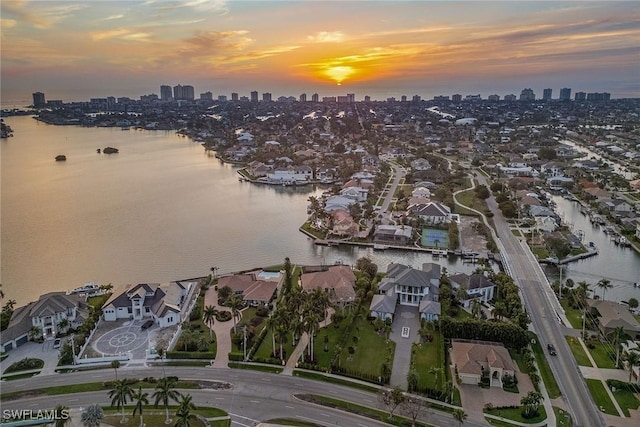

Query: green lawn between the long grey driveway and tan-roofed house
[411,331,446,390]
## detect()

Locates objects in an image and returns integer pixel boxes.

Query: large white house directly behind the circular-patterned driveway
[102,281,198,327]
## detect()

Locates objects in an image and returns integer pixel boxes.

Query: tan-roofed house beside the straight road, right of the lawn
[450,339,516,388]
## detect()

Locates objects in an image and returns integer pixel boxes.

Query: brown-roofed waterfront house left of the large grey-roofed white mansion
[300,265,356,306]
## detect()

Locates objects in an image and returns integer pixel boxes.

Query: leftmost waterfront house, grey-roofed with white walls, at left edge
[1,292,89,351]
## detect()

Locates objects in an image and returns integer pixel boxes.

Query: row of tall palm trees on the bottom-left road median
[107,377,196,427]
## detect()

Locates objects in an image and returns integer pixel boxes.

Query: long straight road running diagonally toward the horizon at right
[479,177,605,427]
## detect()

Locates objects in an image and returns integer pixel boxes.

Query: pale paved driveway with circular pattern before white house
[93,321,149,359]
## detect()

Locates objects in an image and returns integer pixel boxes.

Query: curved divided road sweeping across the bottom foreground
[2,366,487,427]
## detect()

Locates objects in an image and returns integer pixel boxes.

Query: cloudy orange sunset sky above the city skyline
[1,0,640,104]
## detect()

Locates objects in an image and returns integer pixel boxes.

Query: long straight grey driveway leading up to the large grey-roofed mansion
[389,305,420,390]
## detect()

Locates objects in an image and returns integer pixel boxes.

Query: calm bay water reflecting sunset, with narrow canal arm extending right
[0,117,473,305]
